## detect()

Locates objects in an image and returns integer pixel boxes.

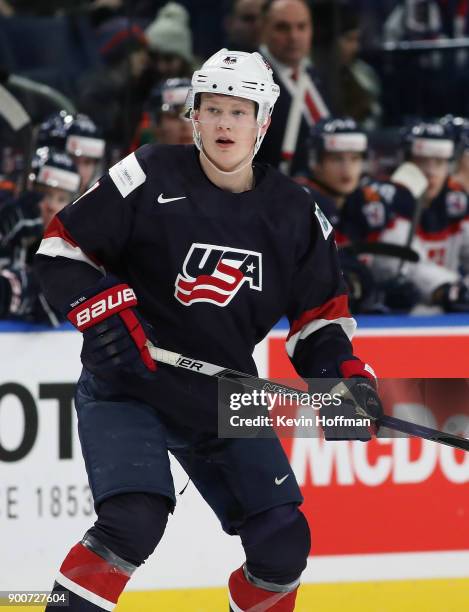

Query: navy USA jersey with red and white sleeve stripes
[36,145,355,377]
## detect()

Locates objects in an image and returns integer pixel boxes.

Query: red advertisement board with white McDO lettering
[268,329,469,556]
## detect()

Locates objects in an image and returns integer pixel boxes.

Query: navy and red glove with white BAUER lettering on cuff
[66,276,156,378]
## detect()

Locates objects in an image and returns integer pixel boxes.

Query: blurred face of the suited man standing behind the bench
[263,0,313,68]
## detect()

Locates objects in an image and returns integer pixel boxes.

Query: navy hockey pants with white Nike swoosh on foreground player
[75,370,303,534]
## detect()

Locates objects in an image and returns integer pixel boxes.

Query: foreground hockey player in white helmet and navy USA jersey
[37,49,381,612]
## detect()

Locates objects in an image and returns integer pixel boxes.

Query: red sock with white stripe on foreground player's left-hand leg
[46,534,136,612]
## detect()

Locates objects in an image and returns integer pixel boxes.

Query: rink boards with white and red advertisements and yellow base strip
[0,317,469,612]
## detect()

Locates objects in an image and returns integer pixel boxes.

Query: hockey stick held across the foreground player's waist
[147,340,469,451]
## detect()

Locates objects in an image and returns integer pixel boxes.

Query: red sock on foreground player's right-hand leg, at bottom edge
[228,565,300,612]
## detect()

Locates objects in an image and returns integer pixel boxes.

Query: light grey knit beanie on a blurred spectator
[145,2,193,63]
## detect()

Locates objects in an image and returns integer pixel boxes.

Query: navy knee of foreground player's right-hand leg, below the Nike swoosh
[239,504,311,584]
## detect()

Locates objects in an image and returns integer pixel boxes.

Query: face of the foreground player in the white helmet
[194,93,268,171]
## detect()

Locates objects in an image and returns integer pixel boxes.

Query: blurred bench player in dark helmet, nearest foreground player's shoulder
[297,117,419,313]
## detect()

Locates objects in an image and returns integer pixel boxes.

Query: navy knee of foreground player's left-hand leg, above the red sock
[88,493,172,565]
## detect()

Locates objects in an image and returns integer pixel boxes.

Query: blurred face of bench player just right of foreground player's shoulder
[314,151,363,195]
